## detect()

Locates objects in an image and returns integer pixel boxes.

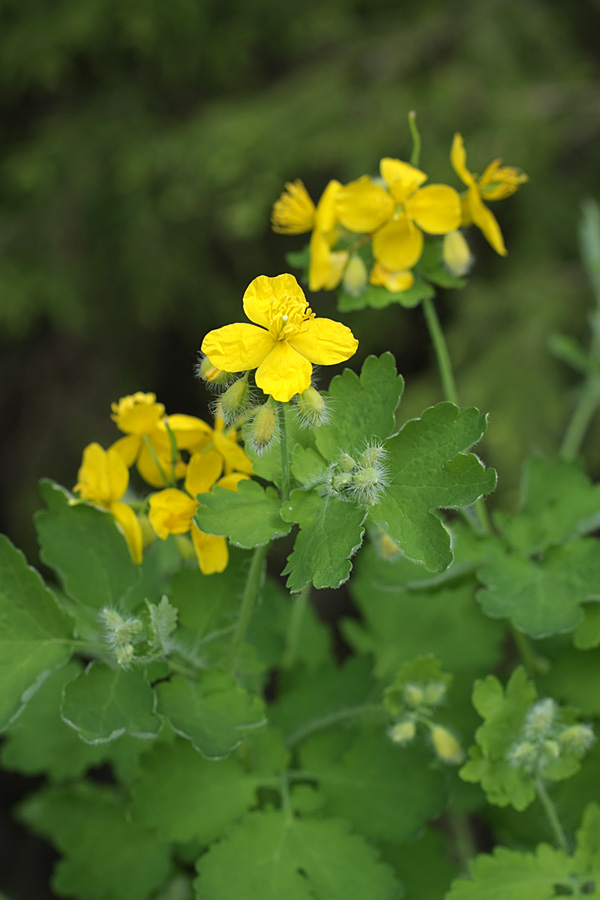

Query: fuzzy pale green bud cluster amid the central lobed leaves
[328,441,389,506]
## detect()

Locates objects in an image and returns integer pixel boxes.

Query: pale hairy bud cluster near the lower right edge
[508,698,594,775]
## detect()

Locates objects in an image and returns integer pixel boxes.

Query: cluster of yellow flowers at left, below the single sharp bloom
[74,392,252,575]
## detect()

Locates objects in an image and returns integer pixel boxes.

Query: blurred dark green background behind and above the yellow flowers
[0,0,600,554]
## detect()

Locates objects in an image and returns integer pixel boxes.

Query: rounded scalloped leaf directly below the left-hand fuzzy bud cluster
[62,663,161,744]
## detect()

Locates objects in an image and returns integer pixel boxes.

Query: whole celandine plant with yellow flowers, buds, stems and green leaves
[0,116,600,900]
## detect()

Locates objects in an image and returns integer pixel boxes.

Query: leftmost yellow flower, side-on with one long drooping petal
[74,443,142,563]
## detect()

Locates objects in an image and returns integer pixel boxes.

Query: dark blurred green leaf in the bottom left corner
[19,783,171,900]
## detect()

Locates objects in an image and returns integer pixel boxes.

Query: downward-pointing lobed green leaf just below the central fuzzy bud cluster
[281,490,365,593]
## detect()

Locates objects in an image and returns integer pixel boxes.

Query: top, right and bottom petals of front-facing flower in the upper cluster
[373,157,461,272]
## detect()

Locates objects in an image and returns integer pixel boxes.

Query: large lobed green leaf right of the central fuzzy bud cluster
[369,402,496,572]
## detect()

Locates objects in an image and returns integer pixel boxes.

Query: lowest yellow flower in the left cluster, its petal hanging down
[148,452,248,575]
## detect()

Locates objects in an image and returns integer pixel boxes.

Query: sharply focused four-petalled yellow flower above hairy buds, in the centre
[202,274,358,402]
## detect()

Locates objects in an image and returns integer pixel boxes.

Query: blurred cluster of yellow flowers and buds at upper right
[272,134,527,296]
